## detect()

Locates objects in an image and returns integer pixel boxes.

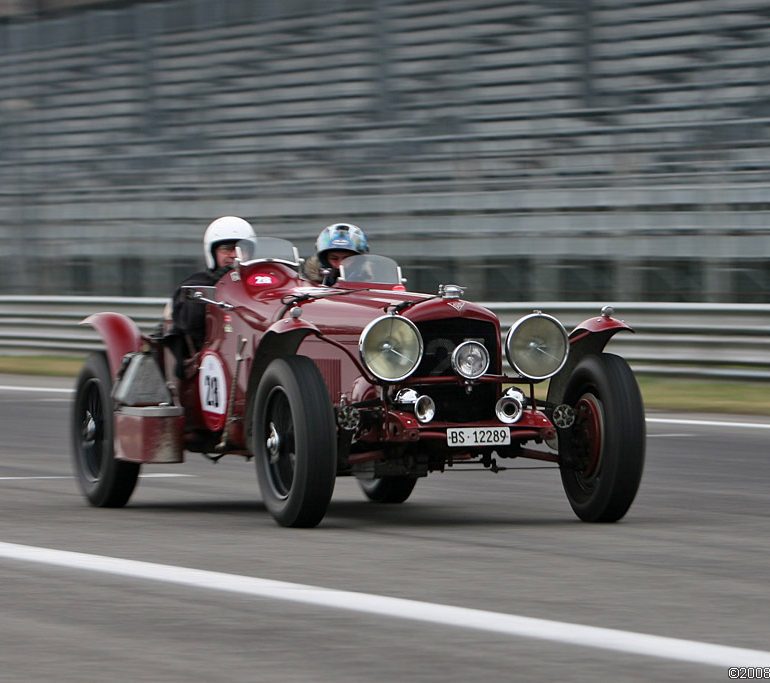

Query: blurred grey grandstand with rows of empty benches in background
[0,0,770,301]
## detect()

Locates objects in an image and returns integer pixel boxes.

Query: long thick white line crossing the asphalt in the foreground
[0,542,770,667]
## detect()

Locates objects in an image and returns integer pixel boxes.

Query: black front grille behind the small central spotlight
[414,318,501,422]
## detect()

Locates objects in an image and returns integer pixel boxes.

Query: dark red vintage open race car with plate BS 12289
[72,237,645,527]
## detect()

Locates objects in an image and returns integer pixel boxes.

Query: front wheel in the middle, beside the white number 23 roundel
[251,356,337,527]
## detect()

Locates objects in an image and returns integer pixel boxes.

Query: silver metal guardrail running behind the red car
[0,295,770,380]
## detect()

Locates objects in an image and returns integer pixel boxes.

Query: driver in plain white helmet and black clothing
[169,216,256,379]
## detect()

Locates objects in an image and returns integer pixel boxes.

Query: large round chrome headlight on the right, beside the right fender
[505,312,569,380]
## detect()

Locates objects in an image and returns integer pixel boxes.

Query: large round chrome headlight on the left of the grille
[358,315,422,382]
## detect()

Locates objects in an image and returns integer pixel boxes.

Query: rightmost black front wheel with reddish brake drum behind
[559,353,646,522]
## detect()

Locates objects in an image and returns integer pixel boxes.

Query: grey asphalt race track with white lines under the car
[0,376,770,683]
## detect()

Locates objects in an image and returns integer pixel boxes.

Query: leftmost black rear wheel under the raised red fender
[71,353,141,507]
